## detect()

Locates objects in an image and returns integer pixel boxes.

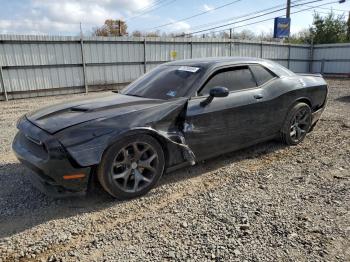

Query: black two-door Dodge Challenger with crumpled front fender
[13,57,328,199]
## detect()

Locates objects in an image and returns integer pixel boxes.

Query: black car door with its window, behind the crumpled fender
[184,65,272,160]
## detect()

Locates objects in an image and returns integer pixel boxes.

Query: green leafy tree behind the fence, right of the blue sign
[310,11,347,44]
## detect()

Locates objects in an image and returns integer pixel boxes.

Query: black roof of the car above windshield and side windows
[163,56,294,76]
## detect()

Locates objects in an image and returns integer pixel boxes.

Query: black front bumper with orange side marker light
[12,118,91,197]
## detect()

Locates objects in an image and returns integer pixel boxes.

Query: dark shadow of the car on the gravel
[0,141,285,238]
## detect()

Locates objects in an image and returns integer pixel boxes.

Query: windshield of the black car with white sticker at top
[121,65,203,99]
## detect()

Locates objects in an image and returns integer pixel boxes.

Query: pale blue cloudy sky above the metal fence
[0,0,350,36]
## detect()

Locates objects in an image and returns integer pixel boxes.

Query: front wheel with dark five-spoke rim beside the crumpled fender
[97,134,165,200]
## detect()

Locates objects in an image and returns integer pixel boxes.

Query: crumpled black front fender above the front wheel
[57,98,196,169]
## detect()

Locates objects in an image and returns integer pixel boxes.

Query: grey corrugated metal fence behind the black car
[0,35,350,100]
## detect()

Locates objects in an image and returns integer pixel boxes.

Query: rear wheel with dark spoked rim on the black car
[281,102,312,145]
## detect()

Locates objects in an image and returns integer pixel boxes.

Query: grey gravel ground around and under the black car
[0,80,350,261]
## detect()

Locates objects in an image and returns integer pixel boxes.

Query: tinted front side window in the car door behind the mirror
[199,66,257,95]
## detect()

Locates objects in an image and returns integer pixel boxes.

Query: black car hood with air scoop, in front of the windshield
[26,93,174,134]
